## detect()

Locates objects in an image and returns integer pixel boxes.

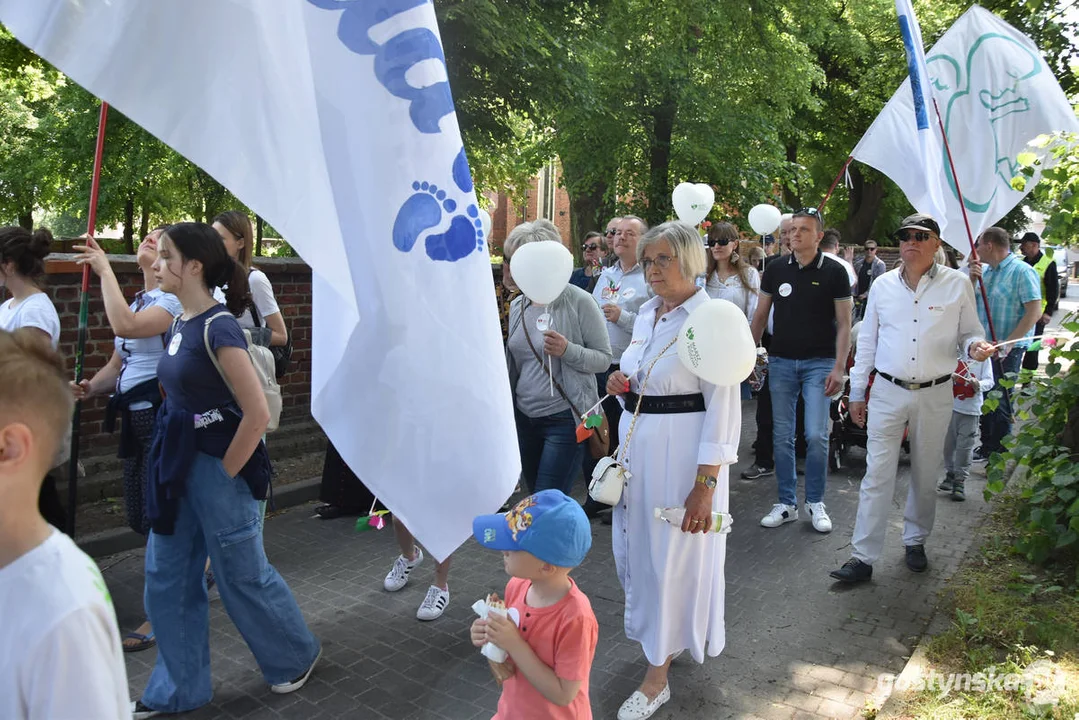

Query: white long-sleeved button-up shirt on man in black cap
[850,264,985,402]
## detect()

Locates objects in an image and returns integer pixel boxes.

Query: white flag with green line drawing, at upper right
[850,0,1079,254]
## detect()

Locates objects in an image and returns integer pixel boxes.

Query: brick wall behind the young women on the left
[14,254,311,457]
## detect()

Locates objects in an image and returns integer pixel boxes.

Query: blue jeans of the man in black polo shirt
[768,357,835,505]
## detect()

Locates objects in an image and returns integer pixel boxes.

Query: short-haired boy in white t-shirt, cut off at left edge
[0,328,132,720]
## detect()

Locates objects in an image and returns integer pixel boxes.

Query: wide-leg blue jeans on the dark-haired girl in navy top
[142,452,319,712]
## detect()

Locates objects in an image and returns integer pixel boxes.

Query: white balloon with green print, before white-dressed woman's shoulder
[678,300,756,385]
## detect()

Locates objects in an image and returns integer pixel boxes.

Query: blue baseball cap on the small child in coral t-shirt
[473,490,592,568]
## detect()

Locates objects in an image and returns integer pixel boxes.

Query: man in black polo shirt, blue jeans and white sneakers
[752,207,851,532]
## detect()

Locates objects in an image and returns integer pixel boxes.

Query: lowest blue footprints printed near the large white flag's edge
[394,148,483,262]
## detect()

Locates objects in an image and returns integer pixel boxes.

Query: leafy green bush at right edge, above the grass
[985,314,1079,567]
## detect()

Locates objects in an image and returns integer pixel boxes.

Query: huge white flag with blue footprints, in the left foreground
[0,0,520,559]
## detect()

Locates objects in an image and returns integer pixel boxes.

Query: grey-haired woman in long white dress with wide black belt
[607,222,741,720]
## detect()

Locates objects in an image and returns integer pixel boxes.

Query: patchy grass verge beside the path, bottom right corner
[865,488,1079,720]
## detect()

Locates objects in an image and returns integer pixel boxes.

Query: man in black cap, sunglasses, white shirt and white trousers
[831,214,993,583]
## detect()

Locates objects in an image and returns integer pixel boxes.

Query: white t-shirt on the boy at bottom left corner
[0,530,131,720]
